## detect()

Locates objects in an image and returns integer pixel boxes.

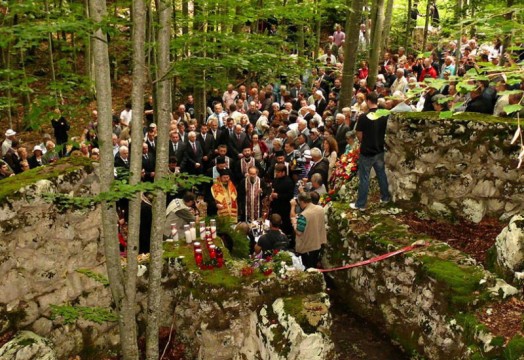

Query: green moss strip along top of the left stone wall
[0,157,93,201]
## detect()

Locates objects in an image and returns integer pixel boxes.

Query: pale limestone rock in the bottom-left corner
[0,331,57,360]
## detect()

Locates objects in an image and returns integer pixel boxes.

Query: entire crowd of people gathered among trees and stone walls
[0,26,524,267]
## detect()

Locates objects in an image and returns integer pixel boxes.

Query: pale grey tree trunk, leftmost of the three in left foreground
[89,0,128,359]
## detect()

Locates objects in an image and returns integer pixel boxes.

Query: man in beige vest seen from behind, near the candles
[291,192,327,269]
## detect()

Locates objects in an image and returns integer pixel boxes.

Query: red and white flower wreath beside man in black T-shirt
[320,147,360,206]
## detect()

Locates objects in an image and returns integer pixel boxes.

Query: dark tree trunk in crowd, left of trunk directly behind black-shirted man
[338,0,365,111]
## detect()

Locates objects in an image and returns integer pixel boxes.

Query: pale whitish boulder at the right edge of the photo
[495,215,524,273]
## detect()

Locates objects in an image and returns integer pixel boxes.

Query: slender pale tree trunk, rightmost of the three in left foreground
[146,0,172,359]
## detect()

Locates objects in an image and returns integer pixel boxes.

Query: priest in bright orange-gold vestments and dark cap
[211,169,238,223]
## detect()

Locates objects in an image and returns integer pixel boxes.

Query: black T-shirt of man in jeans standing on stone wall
[357,109,388,156]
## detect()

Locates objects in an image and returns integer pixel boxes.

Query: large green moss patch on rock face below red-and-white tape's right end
[421,256,484,309]
